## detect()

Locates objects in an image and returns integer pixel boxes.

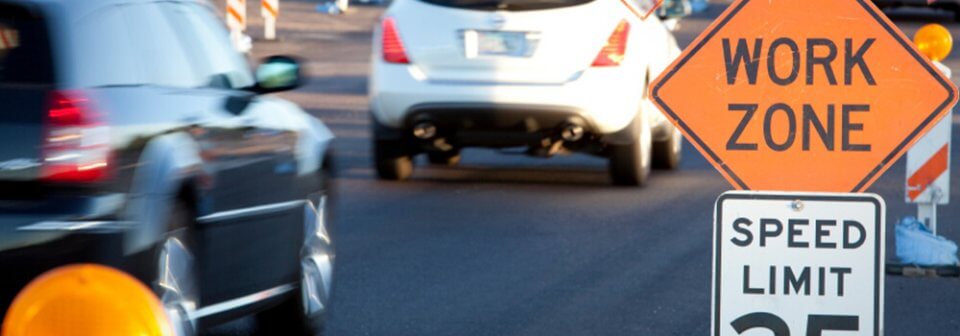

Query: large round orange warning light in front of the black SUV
[3,265,173,336]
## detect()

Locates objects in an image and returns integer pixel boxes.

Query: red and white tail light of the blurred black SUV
[42,91,111,183]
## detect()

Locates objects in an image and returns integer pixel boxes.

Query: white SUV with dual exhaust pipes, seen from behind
[369,0,682,185]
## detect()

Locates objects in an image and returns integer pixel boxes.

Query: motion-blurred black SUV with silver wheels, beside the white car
[0,0,334,334]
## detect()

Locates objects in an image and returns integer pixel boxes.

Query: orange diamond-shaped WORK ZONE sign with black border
[651,0,957,192]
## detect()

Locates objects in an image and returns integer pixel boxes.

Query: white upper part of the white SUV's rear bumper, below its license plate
[370,62,659,134]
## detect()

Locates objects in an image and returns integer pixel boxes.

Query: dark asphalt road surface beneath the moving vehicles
[217,0,960,335]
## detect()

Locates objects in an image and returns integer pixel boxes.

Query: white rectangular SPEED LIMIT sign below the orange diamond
[711,192,885,336]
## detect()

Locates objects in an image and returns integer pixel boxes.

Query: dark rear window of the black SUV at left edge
[0,4,54,85]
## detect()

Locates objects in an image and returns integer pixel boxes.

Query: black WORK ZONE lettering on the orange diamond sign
[723,37,877,152]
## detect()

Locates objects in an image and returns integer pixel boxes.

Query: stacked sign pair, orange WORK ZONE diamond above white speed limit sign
[650,0,957,335]
